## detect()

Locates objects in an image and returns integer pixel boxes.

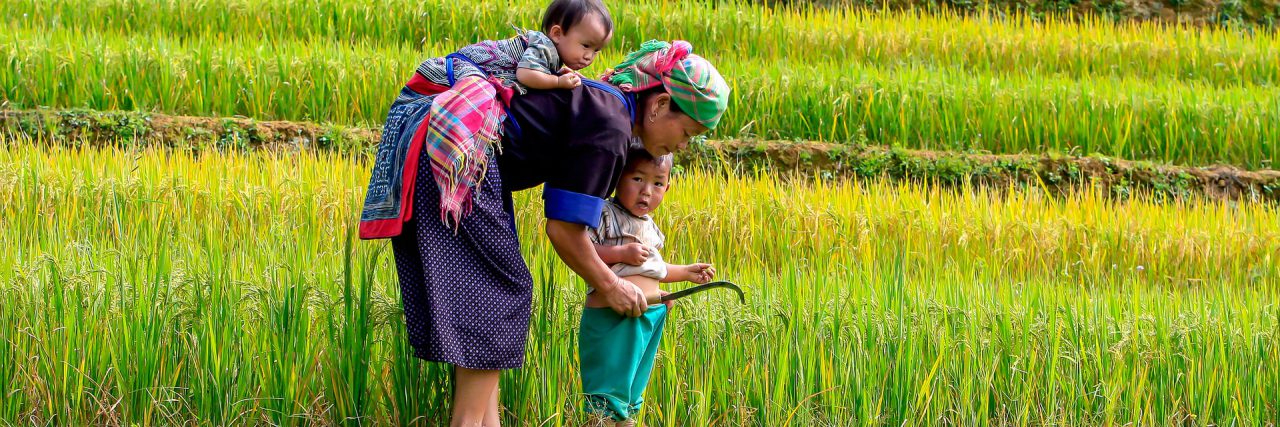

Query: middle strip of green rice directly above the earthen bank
[0,26,1280,167]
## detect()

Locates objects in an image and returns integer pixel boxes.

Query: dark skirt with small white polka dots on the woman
[392,145,532,369]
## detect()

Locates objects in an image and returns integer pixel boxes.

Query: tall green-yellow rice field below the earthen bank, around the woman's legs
[0,139,1280,426]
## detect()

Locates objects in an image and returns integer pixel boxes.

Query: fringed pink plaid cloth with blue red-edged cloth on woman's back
[360,55,511,239]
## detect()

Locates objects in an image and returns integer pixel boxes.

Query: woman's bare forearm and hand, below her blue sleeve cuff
[547,219,648,317]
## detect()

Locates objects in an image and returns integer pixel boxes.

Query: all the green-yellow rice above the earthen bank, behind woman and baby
[0,1,1280,169]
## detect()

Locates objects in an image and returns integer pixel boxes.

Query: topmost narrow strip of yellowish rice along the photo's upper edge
[0,0,1280,86]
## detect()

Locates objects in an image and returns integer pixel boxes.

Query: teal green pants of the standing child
[577,306,667,421]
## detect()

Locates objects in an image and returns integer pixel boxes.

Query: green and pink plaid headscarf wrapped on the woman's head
[604,40,728,129]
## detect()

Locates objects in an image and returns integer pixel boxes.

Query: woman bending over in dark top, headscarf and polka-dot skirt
[361,41,730,426]
